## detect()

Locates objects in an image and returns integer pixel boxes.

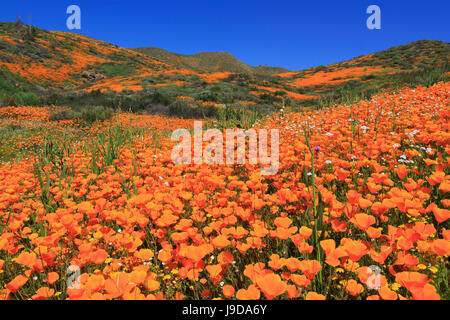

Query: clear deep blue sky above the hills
[0,0,450,70]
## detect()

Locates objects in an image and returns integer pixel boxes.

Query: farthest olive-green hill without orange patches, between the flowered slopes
[133,47,288,75]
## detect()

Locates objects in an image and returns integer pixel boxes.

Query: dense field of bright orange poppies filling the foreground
[0,82,450,300]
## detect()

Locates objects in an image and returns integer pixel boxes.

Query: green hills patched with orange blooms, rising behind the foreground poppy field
[0,23,450,117]
